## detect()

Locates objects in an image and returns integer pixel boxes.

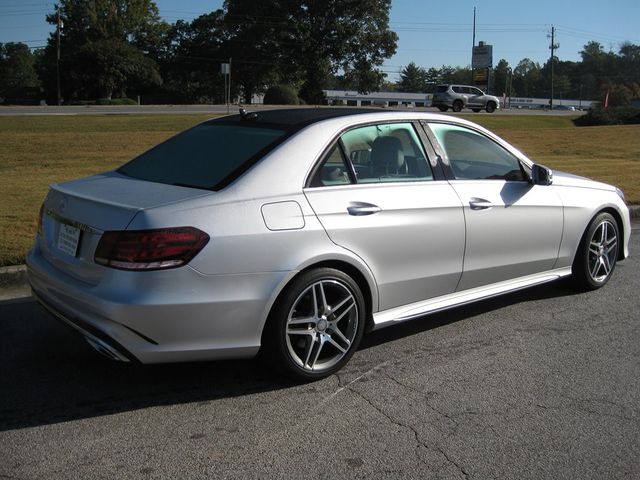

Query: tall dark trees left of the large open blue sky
[0,0,398,103]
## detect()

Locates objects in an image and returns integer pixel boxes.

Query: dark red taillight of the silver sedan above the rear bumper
[94,227,209,270]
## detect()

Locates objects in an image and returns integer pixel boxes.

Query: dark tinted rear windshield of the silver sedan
[118,123,286,190]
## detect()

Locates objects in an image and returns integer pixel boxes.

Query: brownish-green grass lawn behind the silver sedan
[0,114,640,266]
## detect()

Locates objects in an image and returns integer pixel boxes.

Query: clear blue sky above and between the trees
[0,0,640,81]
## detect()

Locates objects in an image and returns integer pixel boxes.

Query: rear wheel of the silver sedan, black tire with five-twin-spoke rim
[263,268,366,381]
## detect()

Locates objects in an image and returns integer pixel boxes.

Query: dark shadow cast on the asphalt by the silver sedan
[0,280,574,431]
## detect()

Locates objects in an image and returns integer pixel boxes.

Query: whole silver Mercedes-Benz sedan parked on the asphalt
[27,108,631,379]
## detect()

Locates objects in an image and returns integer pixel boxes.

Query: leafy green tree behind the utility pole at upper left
[43,0,168,99]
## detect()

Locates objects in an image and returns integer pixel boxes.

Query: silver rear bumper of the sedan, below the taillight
[27,246,289,363]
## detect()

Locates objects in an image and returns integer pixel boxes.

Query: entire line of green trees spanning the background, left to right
[0,0,640,104]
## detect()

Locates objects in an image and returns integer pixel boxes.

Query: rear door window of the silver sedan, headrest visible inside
[340,123,433,183]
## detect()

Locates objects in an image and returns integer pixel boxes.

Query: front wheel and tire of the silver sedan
[571,212,620,290]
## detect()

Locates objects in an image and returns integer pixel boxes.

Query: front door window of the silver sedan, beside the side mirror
[429,123,525,181]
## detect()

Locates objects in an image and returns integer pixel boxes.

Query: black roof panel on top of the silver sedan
[213,107,380,128]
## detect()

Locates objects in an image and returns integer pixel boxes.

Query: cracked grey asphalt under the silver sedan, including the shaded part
[0,231,640,479]
